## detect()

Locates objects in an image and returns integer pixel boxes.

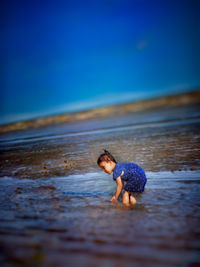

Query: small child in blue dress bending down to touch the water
[97,150,147,206]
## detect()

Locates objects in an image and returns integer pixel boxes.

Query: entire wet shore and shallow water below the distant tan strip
[0,93,200,266]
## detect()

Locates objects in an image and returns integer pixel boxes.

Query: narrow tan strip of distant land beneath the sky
[0,89,200,134]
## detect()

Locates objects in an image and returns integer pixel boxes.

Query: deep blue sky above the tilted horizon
[0,0,200,124]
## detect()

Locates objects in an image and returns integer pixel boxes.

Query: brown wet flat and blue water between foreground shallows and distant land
[0,104,200,179]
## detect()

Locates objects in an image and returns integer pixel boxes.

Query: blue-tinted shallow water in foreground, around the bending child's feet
[0,172,200,266]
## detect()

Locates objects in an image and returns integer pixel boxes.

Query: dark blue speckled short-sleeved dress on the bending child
[113,162,147,193]
